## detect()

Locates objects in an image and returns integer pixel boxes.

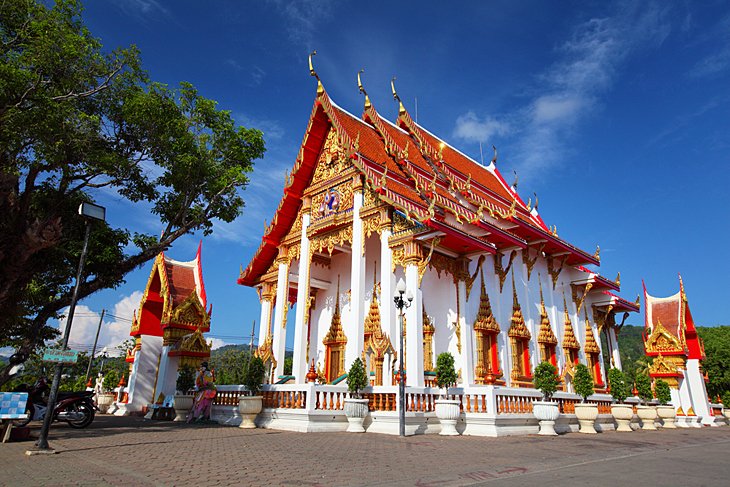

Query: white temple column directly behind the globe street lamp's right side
[406,264,425,387]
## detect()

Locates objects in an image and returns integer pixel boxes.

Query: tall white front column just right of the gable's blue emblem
[343,190,365,372]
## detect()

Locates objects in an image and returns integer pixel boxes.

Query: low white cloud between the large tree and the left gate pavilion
[58,291,142,355]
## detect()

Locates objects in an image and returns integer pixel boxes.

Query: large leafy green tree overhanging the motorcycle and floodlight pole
[0,0,265,385]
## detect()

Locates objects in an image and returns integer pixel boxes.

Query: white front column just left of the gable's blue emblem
[292,207,311,384]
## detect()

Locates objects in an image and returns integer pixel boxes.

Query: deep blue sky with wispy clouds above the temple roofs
[57,0,730,358]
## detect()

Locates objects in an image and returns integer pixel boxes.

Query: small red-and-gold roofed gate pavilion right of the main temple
[643,276,715,425]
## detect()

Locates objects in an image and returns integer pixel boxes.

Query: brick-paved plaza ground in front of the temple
[0,415,730,487]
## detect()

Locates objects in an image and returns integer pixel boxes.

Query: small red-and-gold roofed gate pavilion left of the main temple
[117,244,212,414]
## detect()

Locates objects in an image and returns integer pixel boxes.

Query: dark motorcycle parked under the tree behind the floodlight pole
[14,377,95,428]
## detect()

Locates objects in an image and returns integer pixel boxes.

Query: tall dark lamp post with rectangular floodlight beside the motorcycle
[36,203,106,452]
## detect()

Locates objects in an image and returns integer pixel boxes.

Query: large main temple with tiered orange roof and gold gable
[238,57,639,434]
